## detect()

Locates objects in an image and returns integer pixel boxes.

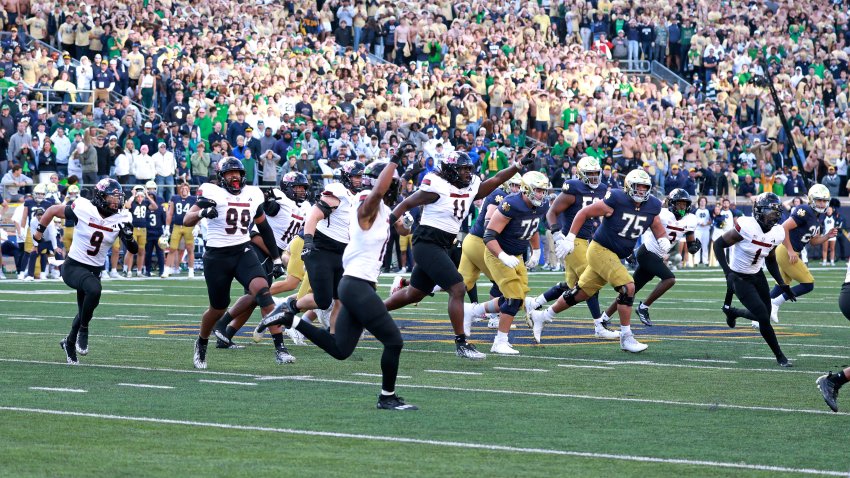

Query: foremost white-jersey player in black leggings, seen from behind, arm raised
[260,161,417,410]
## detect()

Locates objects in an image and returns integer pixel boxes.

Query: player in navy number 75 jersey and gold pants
[526,169,670,353]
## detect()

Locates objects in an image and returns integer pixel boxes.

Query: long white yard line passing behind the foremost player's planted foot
[0,358,850,416]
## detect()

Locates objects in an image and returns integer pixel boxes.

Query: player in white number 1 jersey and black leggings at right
[714,193,797,367]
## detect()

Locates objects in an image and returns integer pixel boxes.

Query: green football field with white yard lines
[0,266,850,477]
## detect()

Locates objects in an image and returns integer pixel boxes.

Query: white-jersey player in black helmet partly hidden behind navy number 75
[604,188,702,327]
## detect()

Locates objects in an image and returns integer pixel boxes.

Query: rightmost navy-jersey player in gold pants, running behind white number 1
[770,184,838,323]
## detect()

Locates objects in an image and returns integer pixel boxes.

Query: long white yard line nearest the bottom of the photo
[0,407,847,476]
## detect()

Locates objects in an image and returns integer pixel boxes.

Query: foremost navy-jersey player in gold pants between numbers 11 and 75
[464,171,552,355]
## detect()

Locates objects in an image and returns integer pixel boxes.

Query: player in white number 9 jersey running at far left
[33,178,139,365]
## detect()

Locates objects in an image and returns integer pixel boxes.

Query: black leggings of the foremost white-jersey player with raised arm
[296,276,404,392]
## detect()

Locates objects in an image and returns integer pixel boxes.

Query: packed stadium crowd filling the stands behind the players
[0,0,850,278]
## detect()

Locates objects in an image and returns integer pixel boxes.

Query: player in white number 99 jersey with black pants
[183,157,283,369]
